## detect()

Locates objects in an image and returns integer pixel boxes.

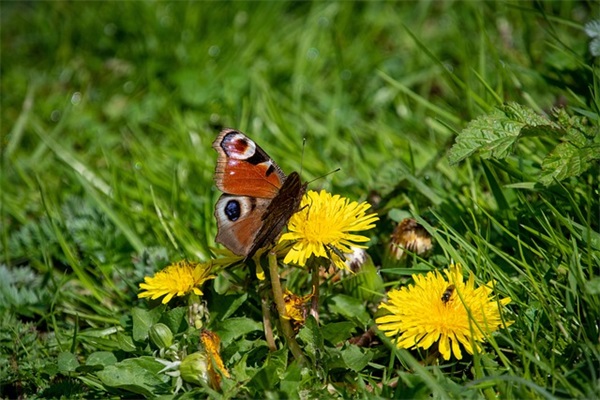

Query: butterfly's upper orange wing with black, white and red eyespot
[213,129,285,199]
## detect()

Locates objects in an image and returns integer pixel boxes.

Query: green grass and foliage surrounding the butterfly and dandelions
[0,2,600,398]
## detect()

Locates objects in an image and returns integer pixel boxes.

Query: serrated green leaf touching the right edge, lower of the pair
[539,142,600,186]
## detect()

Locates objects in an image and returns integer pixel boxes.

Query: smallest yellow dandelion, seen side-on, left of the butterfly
[138,260,215,304]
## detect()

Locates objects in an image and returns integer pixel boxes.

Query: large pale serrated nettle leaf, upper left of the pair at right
[448,103,564,164]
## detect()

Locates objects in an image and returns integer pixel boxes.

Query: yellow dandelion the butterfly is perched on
[280,190,379,269]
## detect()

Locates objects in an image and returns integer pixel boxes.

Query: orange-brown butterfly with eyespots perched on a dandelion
[213,129,307,258]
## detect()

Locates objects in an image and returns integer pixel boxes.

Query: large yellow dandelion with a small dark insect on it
[375,264,511,360]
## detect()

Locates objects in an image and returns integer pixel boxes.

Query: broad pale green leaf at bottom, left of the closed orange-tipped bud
[98,357,171,396]
